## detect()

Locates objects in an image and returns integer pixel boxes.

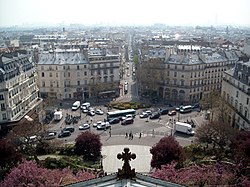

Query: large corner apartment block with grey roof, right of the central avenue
[139,45,238,104]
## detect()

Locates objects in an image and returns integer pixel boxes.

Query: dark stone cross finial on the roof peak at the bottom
[117,148,136,179]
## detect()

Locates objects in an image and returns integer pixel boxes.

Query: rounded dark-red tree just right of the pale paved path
[150,136,184,168]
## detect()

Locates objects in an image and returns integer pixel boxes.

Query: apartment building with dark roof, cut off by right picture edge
[221,61,250,130]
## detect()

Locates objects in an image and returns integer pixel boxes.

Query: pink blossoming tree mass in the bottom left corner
[0,160,95,187]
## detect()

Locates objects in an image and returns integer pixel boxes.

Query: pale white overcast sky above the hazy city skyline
[0,0,250,26]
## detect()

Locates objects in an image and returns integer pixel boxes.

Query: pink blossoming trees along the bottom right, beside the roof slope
[152,162,250,186]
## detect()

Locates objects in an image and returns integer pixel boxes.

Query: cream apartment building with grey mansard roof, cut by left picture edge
[0,51,42,124]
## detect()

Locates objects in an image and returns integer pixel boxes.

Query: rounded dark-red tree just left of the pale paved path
[75,131,102,159]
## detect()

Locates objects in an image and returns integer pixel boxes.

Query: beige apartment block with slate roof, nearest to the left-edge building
[37,49,89,99]
